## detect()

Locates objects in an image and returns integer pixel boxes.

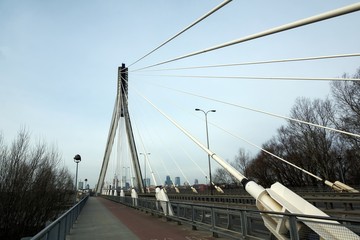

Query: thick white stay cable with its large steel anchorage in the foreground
[138,89,360,240]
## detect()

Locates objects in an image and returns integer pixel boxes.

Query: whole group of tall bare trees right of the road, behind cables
[246,68,360,186]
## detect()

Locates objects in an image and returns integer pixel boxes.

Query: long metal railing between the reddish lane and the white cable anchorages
[104,196,360,239]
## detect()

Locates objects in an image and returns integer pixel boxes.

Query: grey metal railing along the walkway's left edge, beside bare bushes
[30,196,89,240]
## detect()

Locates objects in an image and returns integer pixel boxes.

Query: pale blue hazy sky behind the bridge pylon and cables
[0,0,360,187]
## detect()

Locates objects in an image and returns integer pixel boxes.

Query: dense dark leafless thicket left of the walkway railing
[0,130,73,239]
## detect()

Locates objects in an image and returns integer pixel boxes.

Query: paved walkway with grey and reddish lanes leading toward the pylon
[66,197,214,240]
